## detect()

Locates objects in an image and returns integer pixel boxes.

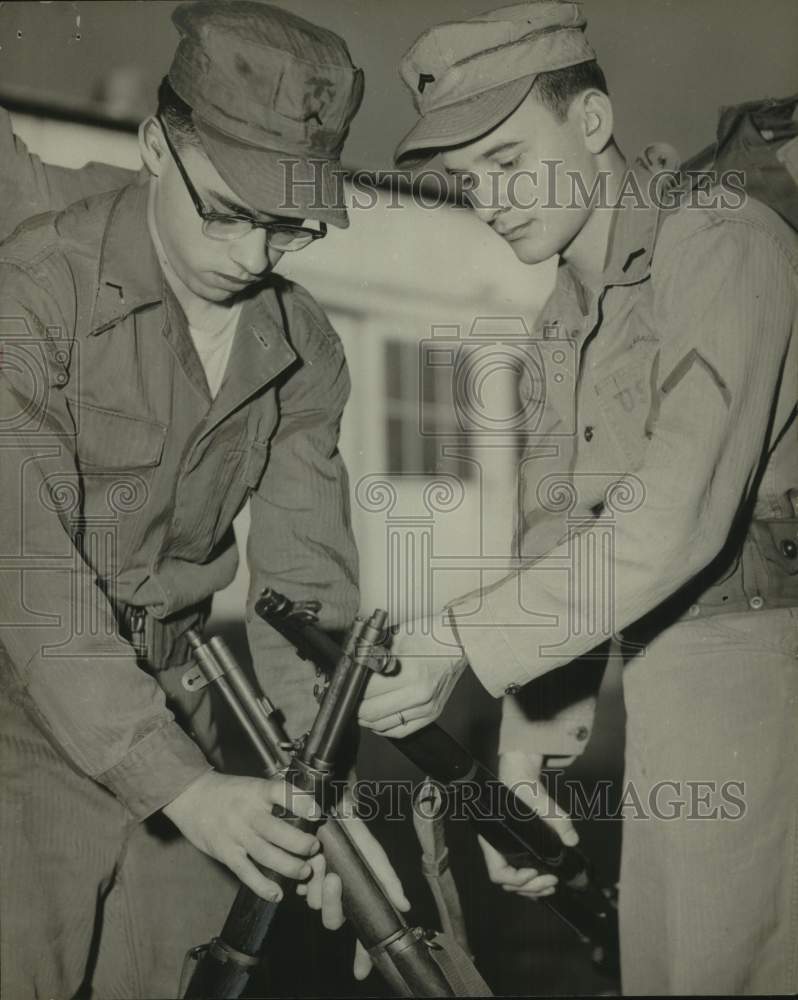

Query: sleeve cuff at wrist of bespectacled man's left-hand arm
[96,722,212,820]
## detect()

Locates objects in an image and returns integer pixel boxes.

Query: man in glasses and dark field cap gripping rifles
[0,0,407,1000]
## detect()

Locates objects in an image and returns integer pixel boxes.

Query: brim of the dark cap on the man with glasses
[194,119,349,229]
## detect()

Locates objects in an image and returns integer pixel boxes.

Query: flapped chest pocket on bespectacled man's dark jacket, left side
[67,399,167,473]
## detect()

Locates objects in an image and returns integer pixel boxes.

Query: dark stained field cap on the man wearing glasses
[169,0,363,227]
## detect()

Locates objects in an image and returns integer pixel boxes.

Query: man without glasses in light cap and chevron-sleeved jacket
[361,0,798,995]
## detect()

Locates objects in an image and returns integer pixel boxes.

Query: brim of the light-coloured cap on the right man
[394,73,537,167]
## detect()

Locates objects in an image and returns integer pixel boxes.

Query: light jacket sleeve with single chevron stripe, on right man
[452,212,796,695]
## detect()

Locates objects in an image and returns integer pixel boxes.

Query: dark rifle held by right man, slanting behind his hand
[255,590,620,979]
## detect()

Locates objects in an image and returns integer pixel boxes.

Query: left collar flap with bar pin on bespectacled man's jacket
[89,182,164,335]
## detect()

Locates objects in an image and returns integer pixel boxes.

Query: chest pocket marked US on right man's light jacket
[596,357,652,471]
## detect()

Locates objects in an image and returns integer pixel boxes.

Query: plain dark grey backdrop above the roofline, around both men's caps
[0,0,798,167]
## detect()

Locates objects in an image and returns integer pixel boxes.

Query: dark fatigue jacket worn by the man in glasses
[0,117,357,817]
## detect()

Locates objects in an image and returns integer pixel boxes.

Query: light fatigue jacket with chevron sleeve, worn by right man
[452,160,798,754]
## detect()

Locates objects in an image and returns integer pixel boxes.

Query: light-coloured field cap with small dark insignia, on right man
[394,0,596,166]
